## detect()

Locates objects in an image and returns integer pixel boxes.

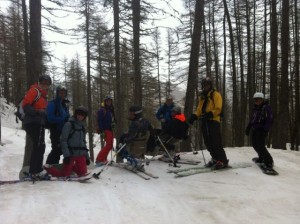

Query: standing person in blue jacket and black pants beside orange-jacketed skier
[46,86,70,164]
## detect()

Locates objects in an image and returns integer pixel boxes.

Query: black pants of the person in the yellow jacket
[202,120,227,162]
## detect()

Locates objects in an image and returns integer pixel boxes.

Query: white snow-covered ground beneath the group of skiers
[0,98,300,224]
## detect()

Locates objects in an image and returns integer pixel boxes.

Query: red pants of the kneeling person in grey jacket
[46,156,87,177]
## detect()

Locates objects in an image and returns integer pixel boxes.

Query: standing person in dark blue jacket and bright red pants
[96,95,115,166]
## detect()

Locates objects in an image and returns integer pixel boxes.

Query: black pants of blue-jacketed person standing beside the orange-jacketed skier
[46,127,62,164]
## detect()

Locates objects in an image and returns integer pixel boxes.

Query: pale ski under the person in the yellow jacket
[173,164,251,177]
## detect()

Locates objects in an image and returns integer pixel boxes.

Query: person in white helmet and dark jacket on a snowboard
[246,92,274,168]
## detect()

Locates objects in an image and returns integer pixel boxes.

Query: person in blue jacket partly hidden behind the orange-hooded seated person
[155,96,175,129]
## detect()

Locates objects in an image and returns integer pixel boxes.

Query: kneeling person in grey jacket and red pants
[44,106,90,177]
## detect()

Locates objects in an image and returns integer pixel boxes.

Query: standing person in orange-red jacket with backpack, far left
[22,75,52,179]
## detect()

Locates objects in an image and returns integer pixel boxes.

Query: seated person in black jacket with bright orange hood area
[148,106,189,161]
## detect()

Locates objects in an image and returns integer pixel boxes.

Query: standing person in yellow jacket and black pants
[189,77,228,169]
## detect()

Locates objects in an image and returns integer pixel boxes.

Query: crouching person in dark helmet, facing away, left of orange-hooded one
[117,106,153,170]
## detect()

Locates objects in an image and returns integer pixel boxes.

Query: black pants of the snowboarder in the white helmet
[252,129,273,164]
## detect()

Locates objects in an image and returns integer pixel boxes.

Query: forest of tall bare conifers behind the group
[0,0,300,165]
